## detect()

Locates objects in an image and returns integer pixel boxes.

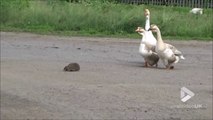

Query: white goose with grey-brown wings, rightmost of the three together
[149,25,185,69]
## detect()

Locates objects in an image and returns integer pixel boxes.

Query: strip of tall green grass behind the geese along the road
[0,0,213,40]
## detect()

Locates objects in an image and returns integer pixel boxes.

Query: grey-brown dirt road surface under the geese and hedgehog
[1,32,213,120]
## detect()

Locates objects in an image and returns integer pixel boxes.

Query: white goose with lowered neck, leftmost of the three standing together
[135,27,159,67]
